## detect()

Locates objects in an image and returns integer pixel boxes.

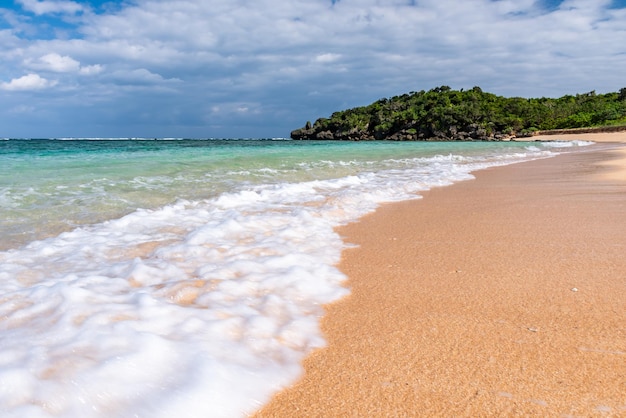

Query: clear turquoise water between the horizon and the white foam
[0,140,548,249]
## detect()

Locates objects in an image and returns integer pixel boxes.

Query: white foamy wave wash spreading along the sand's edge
[0,143,580,417]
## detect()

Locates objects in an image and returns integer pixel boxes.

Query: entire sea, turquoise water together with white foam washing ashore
[0,140,589,417]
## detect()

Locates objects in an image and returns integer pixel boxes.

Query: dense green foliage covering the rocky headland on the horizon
[291,86,626,140]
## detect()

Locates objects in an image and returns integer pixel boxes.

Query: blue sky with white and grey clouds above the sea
[0,0,626,138]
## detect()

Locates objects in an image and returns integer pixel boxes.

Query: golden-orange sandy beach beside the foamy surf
[255,133,626,417]
